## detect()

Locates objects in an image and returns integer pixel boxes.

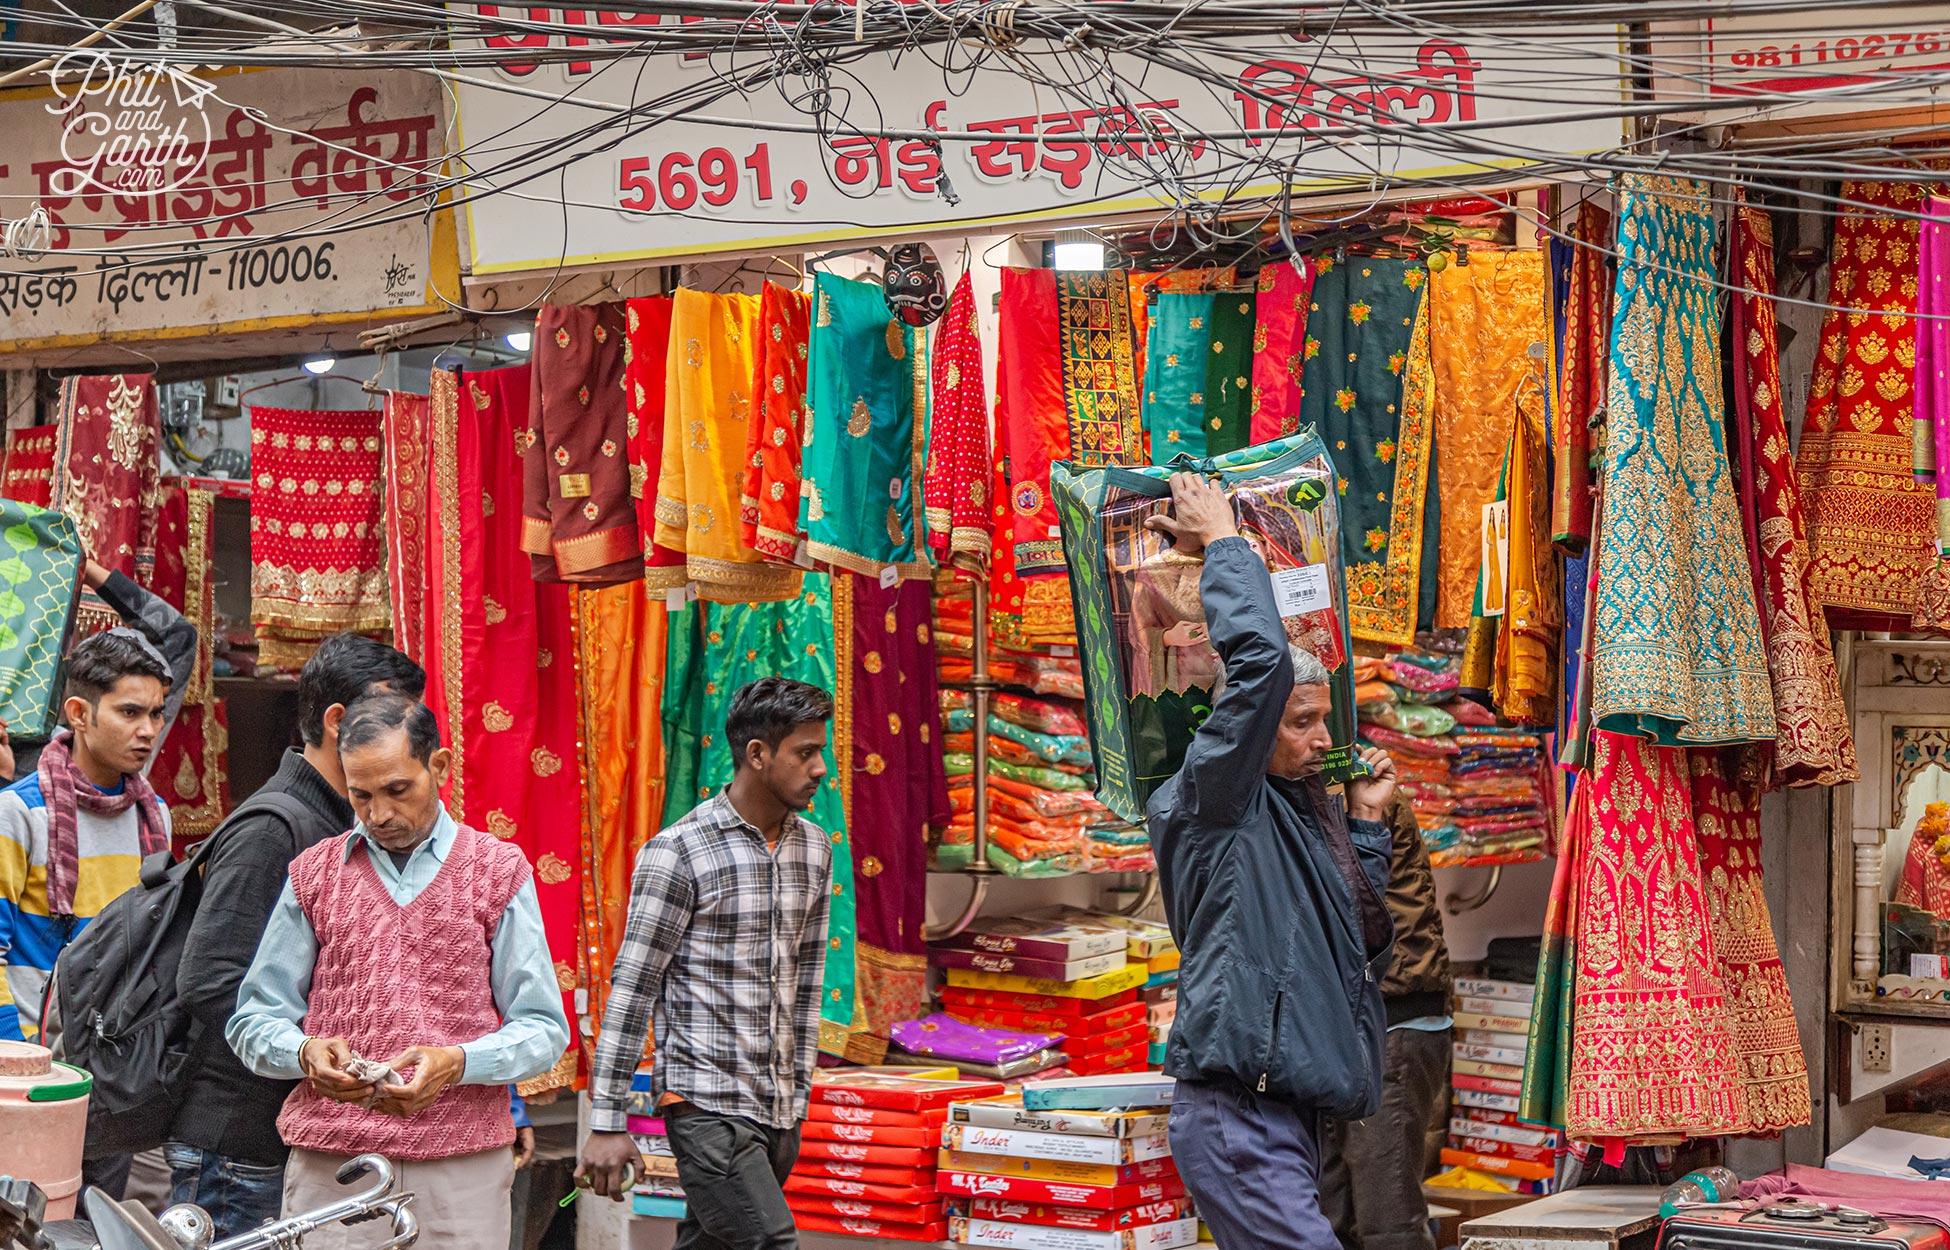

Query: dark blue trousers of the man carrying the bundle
[1172,1080,1340,1250]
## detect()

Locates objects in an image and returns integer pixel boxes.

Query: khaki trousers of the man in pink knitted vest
[285,1147,515,1250]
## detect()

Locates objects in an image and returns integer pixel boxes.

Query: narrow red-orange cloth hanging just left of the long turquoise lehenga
[1550,199,1611,556]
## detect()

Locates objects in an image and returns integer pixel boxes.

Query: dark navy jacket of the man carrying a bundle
[1147,538,1392,1119]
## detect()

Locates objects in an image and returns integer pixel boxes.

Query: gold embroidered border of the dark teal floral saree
[1347,289,1435,645]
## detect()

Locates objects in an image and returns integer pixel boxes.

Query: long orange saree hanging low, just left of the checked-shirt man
[575,583,671,1057]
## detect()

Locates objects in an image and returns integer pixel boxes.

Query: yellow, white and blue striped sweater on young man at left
[0,772,170,1039]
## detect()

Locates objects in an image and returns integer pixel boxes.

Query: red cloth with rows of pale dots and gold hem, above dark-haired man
[250,408,392,671]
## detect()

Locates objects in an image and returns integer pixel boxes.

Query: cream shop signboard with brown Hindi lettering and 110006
[0,66,458,351]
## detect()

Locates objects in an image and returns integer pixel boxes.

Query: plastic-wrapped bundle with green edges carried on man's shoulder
[1051,429,1357,821]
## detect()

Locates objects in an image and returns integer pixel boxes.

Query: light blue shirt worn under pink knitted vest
[224,807,569,1084]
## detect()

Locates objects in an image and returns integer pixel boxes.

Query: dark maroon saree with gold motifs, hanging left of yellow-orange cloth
[521,302,644,585]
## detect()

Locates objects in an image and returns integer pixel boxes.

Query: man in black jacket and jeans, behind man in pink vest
[164,634,427,1238]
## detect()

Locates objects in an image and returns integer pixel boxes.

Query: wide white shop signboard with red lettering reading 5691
[456,15,1620,275]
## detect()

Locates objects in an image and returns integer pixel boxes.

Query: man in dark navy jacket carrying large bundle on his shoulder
[1147,474,1394,1250]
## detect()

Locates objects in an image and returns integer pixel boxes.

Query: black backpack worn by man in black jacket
[41,790,312,1158]
